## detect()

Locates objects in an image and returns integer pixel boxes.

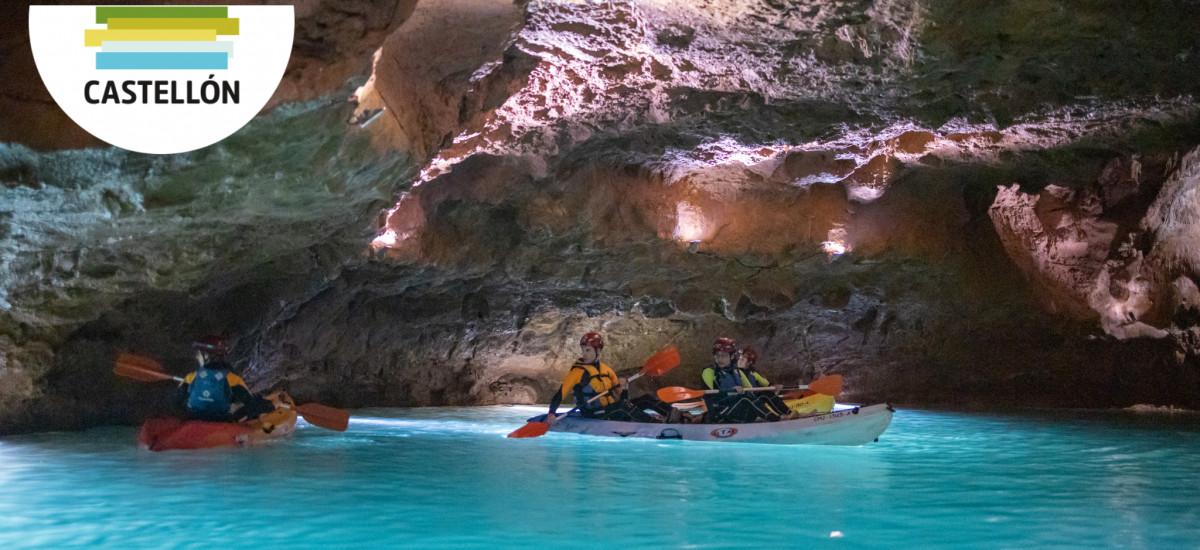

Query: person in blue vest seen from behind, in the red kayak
[175,336,275,422]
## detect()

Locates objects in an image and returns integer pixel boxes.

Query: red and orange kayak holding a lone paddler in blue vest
[138,407,296,450]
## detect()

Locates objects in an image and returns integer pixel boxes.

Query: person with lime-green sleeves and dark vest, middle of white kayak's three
[701,337,780,424]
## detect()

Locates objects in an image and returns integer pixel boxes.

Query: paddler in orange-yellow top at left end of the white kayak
[546,333,655,425]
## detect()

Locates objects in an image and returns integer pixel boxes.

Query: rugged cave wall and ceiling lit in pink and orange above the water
[0,0,1200,432]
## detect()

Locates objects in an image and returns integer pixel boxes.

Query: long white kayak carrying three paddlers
[529,403,895,446]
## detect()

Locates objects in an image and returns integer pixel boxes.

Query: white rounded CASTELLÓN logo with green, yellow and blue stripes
[29,6,295,154]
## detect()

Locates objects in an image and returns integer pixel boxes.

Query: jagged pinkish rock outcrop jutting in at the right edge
[991,150,1200,353]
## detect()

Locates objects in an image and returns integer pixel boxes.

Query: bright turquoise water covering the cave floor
[0,407,1200,550]
